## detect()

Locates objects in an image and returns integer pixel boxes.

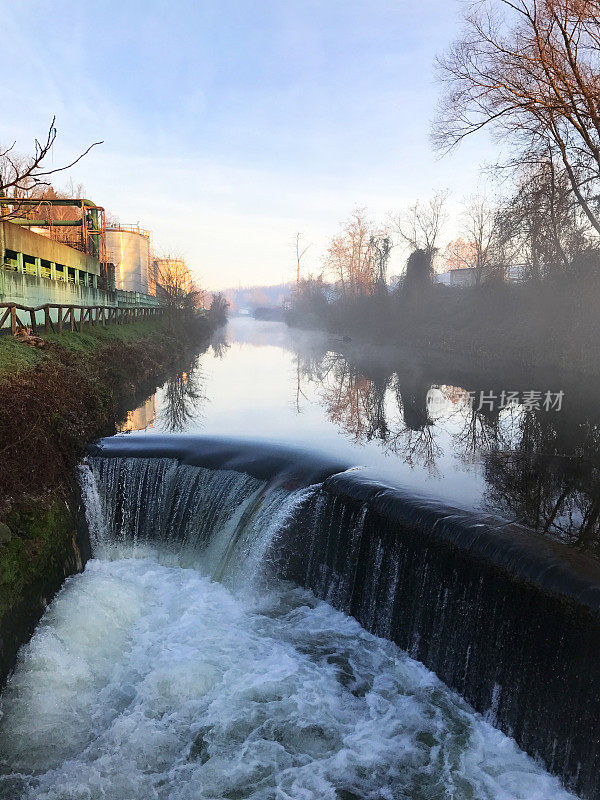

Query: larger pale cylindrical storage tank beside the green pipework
[106,228,151,294]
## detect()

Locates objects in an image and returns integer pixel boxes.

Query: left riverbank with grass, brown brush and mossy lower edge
[0,316,220,685]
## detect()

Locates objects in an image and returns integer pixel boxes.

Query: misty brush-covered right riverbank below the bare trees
[287,276,600,376]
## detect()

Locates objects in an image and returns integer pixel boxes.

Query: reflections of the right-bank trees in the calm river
[298,353,600,547]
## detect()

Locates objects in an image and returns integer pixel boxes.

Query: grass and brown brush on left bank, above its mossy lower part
[0,321,210,496]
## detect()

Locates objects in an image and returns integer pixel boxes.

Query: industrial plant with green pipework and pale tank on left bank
[0,196,159,318]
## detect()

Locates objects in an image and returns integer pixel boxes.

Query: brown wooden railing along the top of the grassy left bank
[0,303,164,336]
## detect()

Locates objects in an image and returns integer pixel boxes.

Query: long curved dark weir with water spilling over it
[82,436,600,798]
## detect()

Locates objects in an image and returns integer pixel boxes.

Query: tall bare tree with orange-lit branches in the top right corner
[434,0,600,233]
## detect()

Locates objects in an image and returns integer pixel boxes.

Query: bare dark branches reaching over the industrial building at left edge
[0,117,102,219]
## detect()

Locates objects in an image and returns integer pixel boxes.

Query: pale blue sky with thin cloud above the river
[0,0,494,289]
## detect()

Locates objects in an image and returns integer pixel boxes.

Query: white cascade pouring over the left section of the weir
[80,457,317,587]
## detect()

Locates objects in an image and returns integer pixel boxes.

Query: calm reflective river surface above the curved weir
[121,317,600,553]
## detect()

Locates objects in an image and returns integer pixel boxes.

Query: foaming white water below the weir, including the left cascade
[0,459,572,800]
